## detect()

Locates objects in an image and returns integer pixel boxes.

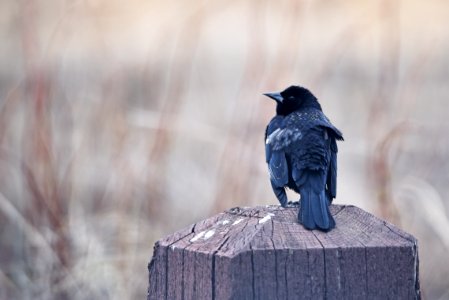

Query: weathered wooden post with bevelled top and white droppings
[148,205,420,300]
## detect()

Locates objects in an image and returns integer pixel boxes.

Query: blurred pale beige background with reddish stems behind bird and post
[0,0,449,299]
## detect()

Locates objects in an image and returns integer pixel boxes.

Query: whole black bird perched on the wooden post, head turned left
[264,86,343,231]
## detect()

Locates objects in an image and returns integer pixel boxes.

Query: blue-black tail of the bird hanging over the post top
[298,180,335,231]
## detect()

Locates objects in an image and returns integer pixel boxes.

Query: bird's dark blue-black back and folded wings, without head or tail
[265,108,343,198]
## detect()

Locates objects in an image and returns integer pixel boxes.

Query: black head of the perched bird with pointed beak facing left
[264,85,321,116]
